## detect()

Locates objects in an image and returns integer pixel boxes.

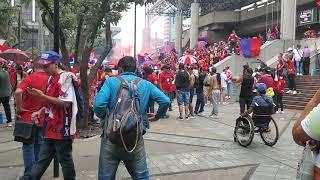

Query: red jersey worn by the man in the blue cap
[45,74,76,140]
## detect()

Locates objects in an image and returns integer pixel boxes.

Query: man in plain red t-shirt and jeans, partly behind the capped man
[15,63,48,177]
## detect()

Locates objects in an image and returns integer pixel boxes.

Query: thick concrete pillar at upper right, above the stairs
[280,0,297,41]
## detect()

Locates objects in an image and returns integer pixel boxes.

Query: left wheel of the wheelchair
[234,117,254,147]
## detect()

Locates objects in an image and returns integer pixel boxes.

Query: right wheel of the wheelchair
[260,118,279,146]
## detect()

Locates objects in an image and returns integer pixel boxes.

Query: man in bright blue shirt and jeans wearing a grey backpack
[94,56,170,180]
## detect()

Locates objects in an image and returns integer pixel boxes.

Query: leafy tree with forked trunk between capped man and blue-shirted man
[24,0,154,128]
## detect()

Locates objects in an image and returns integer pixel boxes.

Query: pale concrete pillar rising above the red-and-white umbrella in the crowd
[190,1,199,49]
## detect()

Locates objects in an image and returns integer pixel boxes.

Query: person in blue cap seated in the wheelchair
[241,83,274,129]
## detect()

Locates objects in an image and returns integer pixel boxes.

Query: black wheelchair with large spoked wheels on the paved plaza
[233,107,279,147]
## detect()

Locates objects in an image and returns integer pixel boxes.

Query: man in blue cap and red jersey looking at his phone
[28,51,78,180]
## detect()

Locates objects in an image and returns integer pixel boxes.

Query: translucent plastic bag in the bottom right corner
[297,142,315,180]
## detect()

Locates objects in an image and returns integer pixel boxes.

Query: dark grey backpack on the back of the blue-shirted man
[106,76,143,153]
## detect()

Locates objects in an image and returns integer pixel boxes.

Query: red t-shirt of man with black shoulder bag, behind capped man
[18,71,48,127]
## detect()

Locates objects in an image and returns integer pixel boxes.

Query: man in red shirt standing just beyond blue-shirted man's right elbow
[159,65,175,111]
